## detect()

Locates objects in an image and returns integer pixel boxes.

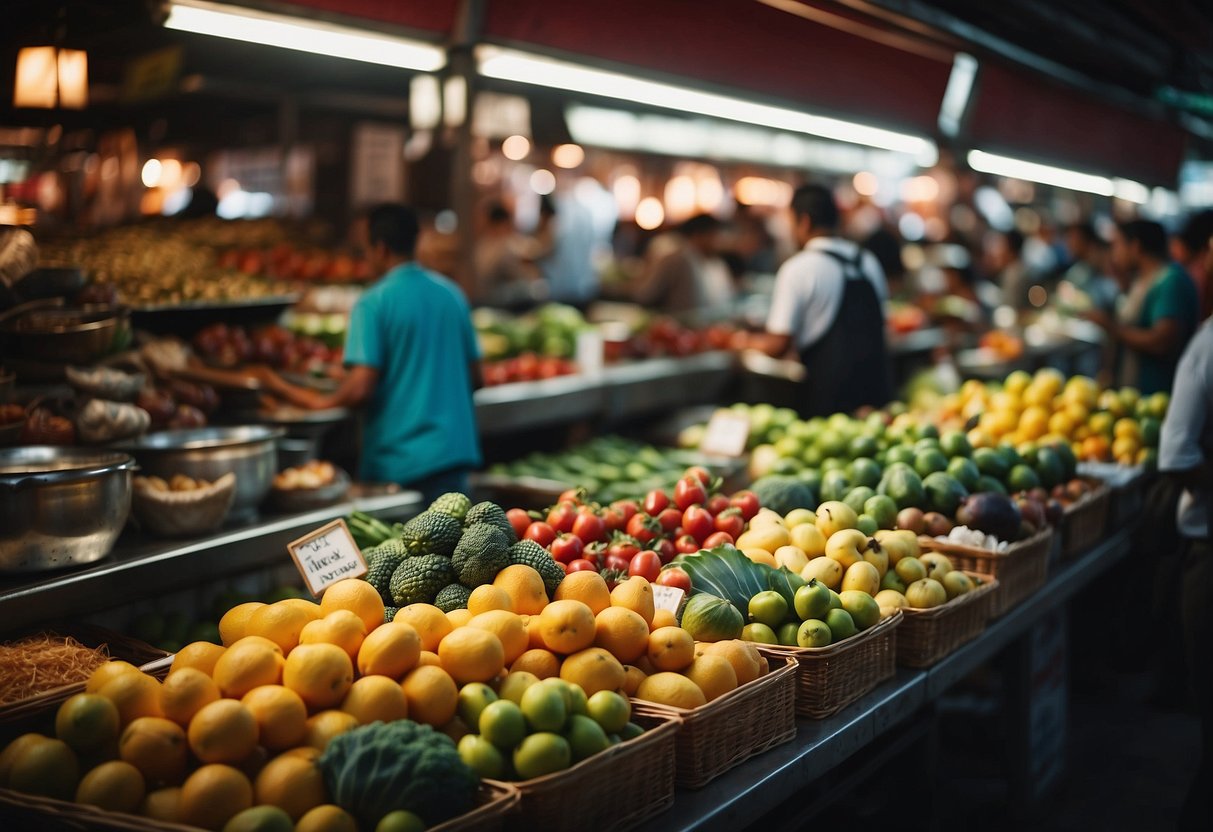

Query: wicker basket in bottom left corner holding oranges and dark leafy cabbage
[0,781,519,832]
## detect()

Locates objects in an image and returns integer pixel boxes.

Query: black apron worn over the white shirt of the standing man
[801,249,893,417]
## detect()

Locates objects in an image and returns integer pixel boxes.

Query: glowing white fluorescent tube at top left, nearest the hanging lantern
[165,0,446,72]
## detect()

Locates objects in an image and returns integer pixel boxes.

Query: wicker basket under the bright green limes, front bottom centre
[486,714,682,832]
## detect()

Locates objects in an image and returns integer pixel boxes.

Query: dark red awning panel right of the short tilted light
[968,63,1185,188]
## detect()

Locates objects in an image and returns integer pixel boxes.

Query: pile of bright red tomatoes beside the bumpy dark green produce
[507,466,761,592]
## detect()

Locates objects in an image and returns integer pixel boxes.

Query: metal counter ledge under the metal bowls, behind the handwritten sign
[0,491,421,632]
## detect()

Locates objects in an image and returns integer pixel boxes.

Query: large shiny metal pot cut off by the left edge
[0,445,135,572]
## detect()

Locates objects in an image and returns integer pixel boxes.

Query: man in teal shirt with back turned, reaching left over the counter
[249,205,482,501]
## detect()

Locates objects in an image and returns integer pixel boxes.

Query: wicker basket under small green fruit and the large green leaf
[758,610,902,719]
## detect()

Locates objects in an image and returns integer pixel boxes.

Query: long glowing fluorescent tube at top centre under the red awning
[477,46,936,165]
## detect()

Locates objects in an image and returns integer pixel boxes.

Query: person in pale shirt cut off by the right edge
[1158,321,1213,830]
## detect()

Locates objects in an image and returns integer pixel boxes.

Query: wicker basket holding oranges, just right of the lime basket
[632,656,797,788]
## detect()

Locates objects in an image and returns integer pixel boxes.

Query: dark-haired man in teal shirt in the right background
[1087,220,1198,395]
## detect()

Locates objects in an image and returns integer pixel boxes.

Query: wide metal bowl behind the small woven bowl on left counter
[114,424,284,519]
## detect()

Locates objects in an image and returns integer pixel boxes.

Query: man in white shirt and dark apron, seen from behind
[751,184,893,416]
